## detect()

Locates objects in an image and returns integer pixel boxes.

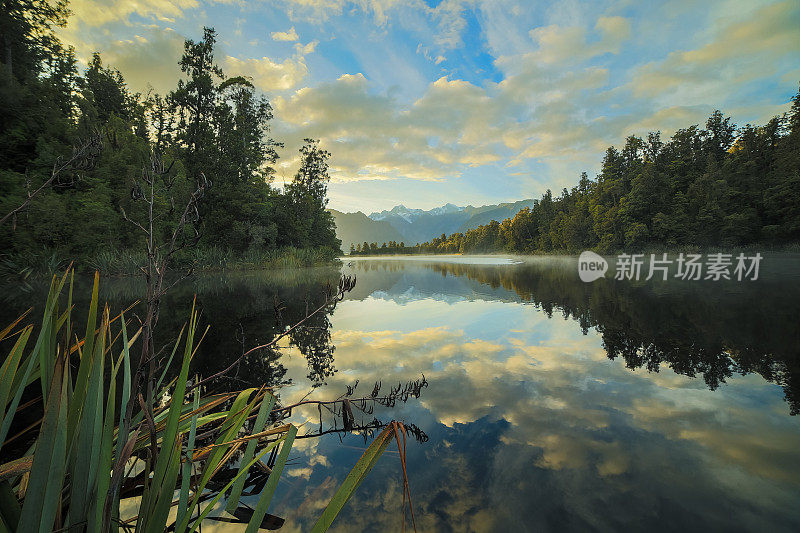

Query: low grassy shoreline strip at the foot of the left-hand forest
[0,246,340,278]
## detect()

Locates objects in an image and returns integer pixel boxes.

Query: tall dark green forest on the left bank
[0,2,340,270]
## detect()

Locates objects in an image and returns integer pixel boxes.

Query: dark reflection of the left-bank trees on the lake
[162,268,346,387]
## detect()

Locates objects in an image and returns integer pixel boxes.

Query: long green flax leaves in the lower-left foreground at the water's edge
[0,271,410,532]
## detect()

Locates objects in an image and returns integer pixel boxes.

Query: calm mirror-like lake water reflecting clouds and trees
[3,255,800,531]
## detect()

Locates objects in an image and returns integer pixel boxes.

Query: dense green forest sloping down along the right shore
[351,98,800,254]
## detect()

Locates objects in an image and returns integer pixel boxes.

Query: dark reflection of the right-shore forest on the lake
[376,258,800,415]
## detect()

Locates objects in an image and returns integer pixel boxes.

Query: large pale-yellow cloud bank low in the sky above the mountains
[268,13,630,187]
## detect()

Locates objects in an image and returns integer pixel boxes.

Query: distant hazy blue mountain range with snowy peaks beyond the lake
[329,200,533,252]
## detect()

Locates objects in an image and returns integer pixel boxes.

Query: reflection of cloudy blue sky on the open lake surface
[264,256,800,531]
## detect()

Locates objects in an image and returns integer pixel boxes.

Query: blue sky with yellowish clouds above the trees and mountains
[61,0,800,213]
